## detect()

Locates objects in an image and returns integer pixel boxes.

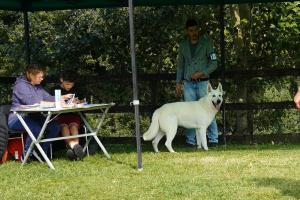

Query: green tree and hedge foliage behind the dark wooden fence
[0,2,300,135]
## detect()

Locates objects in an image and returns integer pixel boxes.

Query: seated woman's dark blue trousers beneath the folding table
[8,115,60,154]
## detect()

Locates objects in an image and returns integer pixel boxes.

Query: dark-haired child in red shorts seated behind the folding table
[51,71,84,160]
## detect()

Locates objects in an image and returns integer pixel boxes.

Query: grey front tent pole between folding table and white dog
[128,0,143,171]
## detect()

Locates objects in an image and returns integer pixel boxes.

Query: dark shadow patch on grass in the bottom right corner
[253,177,300,199]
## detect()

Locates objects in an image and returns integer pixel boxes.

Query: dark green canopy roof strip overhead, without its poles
[0,0,292,11]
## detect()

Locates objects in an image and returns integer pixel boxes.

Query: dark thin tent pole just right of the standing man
[219,4,227,147]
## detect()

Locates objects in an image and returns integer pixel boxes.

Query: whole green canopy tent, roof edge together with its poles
[0,0,292,170]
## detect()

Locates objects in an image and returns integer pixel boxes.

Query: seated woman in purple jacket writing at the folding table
[8,65,70,160]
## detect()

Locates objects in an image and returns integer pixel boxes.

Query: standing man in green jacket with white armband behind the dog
[176,19,218,147]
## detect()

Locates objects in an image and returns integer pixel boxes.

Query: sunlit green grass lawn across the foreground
[0,145,300,200]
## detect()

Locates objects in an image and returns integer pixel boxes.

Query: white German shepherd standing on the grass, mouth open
[143,83,223,152]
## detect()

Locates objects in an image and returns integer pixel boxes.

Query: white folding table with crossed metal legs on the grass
[13,103,115,169]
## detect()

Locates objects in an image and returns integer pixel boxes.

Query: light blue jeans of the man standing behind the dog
[183,80,218,145]
